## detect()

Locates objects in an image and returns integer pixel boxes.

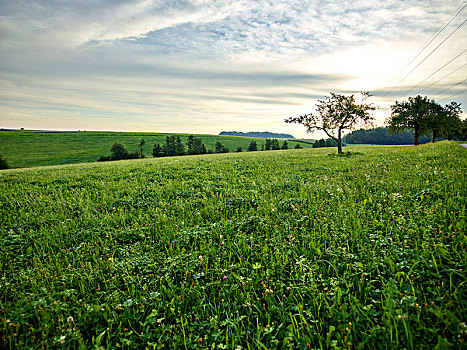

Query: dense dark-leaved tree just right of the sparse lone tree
[386,95,440,146]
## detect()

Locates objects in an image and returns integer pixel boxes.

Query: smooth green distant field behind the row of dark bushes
[0,130,312,168]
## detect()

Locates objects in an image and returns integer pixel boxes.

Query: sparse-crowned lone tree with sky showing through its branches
[285,92,376,153]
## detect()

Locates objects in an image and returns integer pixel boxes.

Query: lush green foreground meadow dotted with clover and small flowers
[0,139,467,349]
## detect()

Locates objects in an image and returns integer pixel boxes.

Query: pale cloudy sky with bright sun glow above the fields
[0,0,467,138]
